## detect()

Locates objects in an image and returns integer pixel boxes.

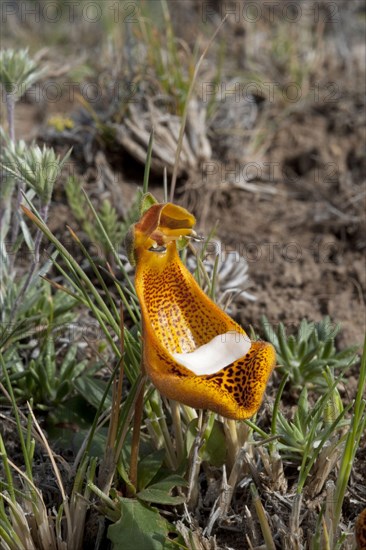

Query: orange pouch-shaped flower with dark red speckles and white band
[127,196,275,419]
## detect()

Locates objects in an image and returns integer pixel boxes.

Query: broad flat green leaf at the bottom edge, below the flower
[108,498,172,550]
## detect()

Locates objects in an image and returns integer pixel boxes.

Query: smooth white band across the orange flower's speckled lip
[172,331,252,376]
